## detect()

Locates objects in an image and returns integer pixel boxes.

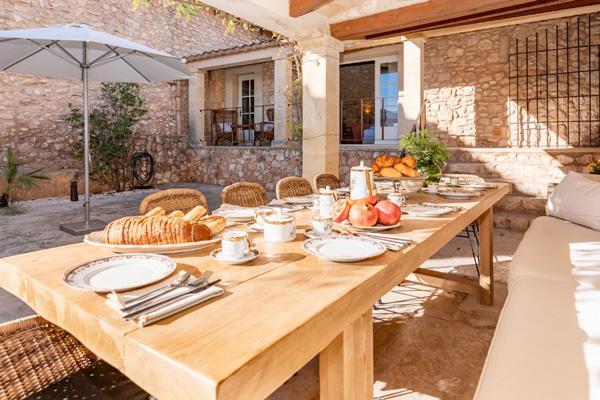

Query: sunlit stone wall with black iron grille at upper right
[425,14,600,147]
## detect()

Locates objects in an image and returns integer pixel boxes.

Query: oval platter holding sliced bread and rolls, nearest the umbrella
[83,206,227,254]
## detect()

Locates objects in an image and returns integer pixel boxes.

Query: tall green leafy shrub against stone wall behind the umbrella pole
[65,83,148,192]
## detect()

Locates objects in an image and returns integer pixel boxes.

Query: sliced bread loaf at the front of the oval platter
[104,215,212,245]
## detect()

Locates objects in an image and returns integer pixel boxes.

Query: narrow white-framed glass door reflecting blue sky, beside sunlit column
[375,57,399,144]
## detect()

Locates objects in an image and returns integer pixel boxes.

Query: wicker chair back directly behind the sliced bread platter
[139,189,208,215]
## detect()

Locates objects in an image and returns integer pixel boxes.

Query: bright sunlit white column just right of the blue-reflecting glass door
[399,38,425,133]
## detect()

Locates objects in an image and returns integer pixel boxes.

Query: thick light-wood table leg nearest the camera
[319,309,373,400]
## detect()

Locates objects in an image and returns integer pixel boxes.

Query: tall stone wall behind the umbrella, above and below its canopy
[0,0,268,189]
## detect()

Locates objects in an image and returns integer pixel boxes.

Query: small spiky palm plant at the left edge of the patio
[0,147,48,207]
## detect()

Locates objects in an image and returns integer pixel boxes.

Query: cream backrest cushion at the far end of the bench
[546,172,600,231]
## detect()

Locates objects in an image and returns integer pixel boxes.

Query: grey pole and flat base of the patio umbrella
[60,42,106,235]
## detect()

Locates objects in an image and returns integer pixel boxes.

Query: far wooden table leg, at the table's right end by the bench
[477,208,494,306]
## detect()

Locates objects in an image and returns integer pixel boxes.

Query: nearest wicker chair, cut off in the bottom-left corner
[0,316,148,400]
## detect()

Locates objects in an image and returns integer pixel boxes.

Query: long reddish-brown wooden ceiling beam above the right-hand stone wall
[331,0,600,40]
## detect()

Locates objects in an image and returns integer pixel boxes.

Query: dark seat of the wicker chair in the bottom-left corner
[28,361,148,400]
